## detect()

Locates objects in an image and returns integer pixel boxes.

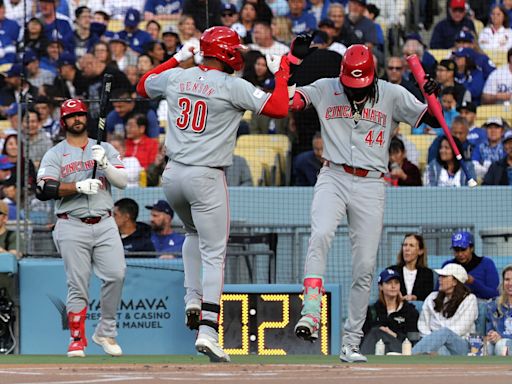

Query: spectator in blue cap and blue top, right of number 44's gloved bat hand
[452,48,485,105]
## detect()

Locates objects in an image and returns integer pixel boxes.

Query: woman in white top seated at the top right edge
[478,5,512,51]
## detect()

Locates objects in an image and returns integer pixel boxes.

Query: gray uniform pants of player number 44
[304,165,385,346]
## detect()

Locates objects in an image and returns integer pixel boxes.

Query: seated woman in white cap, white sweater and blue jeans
[412,263,478,356]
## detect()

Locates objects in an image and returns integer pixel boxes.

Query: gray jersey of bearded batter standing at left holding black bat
[37,139,124,217]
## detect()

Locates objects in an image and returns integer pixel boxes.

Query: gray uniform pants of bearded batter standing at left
[53,216,126,337]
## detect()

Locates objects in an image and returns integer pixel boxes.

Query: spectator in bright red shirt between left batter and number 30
[125,114,158,169]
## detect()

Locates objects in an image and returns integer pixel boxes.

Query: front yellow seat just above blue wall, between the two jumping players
[235,146,279,187]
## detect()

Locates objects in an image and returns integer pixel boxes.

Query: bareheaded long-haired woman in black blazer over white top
[390,233,434,301]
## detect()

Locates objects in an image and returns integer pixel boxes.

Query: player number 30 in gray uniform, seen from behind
[137,27,296,362]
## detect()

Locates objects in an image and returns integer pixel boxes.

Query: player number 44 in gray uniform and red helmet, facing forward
[291,44,439,362]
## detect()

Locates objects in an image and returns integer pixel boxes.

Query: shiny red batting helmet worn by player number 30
[200,27,244,71]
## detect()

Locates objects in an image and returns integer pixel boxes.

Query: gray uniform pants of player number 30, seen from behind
[162,162,229,320]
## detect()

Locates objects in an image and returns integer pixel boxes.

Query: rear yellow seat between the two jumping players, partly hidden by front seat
[236,134,291,185]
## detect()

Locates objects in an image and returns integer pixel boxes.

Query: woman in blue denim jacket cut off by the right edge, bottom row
[485,265,512,356]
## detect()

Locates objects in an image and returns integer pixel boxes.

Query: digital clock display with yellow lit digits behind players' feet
[219,292,331,356]
